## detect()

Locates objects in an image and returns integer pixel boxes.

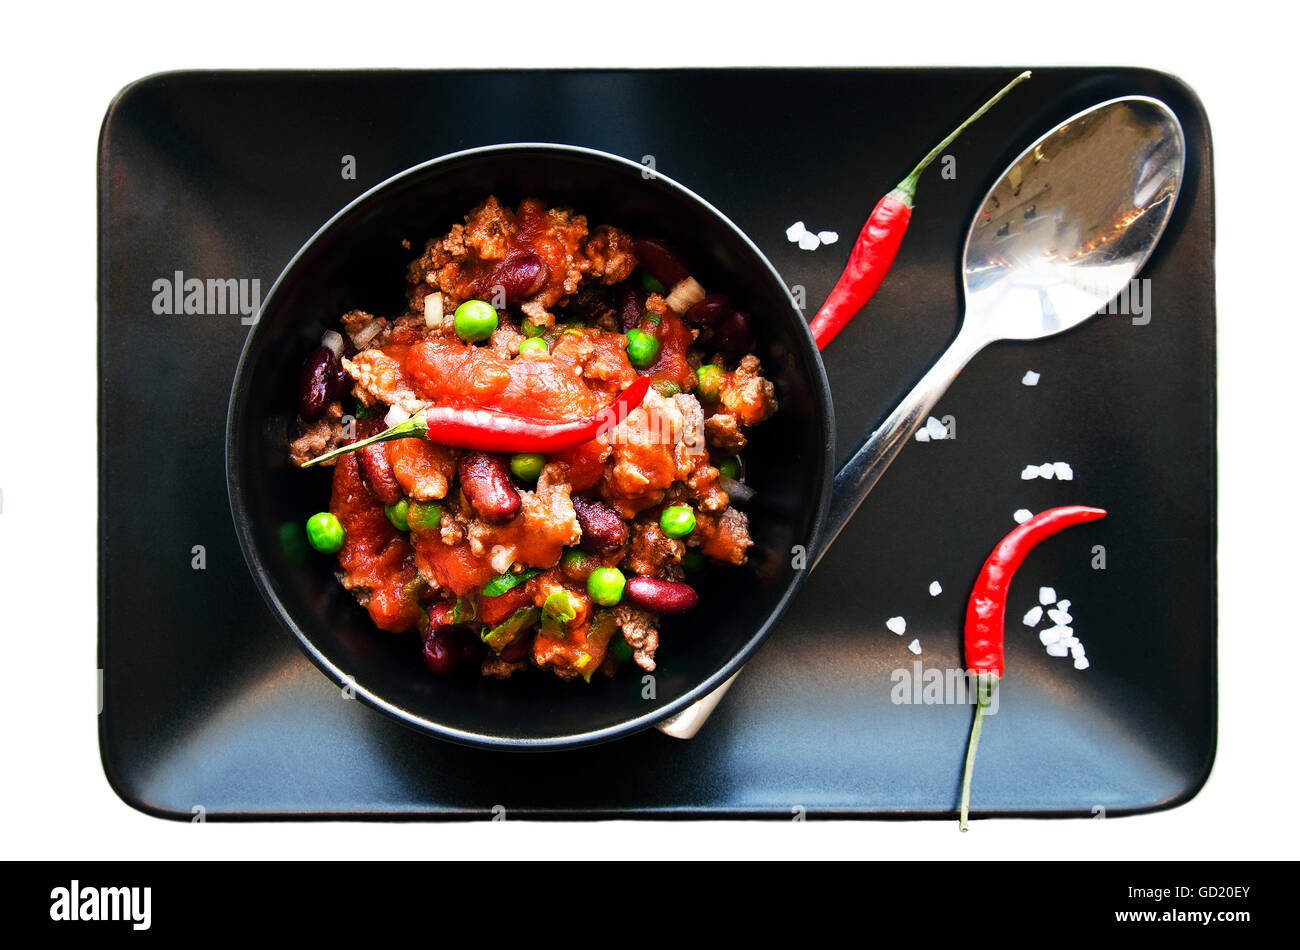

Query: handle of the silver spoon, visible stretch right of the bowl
[810,327,987,569]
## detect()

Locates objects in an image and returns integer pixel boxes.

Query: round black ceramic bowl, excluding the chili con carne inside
[226,144,833,749]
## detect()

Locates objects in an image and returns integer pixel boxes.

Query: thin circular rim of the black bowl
[225,142,836,751]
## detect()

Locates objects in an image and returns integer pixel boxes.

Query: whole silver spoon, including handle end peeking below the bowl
[658,96,1186,738]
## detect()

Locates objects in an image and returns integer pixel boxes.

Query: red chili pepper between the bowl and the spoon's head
[809,70,1030,350]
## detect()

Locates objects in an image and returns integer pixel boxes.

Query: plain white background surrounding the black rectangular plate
[0,0,1300,859]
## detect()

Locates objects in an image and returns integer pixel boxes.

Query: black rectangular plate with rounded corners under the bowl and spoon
[99,69,1216,819]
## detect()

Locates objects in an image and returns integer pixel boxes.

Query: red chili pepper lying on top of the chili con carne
[303,376,650,468]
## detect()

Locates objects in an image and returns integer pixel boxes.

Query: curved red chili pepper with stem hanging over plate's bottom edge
[958,504,1106,832]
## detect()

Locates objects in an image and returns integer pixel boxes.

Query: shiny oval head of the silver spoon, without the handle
[962,96,1186,340]
